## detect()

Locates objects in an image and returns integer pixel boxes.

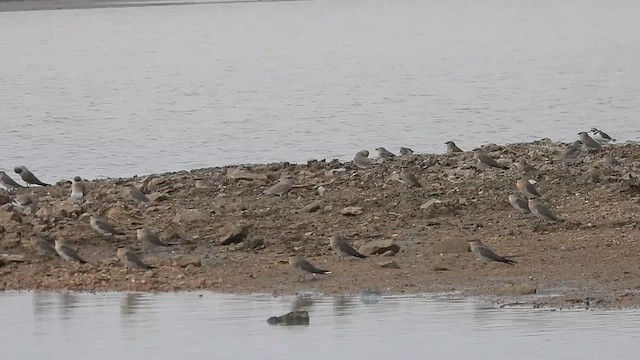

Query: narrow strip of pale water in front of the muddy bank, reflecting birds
[0,292,640,360]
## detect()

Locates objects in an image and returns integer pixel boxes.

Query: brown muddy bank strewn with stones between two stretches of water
[0,140,640,308]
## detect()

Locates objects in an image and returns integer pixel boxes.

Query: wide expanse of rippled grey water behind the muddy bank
[0,0,640,181]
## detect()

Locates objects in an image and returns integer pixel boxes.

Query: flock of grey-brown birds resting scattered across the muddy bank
[0,128,615,280]
